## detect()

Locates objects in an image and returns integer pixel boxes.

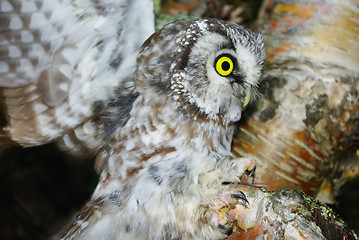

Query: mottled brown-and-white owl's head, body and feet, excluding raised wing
[56,19,265,239]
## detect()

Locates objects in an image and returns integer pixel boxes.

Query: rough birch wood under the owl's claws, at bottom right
[228,185,357,240]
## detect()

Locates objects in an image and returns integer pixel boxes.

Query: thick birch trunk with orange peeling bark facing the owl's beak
[234,0,359,203]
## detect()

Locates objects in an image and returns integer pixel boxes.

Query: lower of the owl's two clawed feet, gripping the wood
[213,191,249,234]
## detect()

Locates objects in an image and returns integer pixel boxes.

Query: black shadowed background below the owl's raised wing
[0,144,98,239]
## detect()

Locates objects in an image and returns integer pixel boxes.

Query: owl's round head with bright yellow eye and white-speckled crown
[136,19,265,124]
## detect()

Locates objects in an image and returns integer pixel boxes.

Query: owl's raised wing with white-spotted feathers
[0,0,154,146]
